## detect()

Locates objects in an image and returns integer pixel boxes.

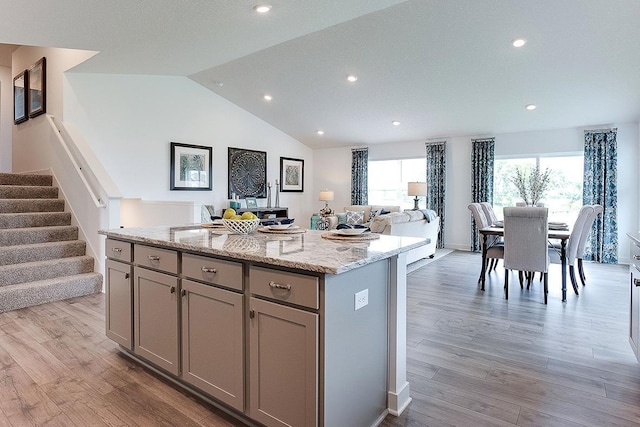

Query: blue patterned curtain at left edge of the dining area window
[471,138,495,252]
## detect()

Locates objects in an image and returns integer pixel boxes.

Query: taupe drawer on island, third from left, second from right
[182,254,243,291]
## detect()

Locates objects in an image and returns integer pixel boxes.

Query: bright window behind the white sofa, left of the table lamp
[369,157,427,209]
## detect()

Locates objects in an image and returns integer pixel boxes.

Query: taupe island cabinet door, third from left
[181,279,244,411]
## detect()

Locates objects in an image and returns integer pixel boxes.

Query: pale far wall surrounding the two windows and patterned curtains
[314,123,640,263]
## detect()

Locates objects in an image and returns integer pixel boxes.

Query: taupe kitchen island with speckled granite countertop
[100,225,429,426]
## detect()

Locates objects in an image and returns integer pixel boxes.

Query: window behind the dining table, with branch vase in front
[493,154,584,224]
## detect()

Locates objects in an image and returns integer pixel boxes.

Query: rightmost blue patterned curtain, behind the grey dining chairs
[582,129,618,264]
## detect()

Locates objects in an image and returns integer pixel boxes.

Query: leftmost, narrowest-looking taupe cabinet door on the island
[105,259,133,350]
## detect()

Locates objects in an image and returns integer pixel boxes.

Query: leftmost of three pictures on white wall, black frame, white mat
[170,142,213,191]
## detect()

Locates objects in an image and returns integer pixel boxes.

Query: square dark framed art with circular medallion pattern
[228,147,267,199]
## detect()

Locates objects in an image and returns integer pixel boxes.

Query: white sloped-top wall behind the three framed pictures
[64,73,313,223]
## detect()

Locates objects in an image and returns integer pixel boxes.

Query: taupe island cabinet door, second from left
[133,267,179,375]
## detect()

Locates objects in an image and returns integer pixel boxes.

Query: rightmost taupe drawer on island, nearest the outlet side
[249,267,319,309]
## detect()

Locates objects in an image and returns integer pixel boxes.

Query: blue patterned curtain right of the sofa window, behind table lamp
[425,141,447,248]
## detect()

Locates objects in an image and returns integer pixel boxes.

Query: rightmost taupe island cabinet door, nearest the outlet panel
[249,298,318,426]
